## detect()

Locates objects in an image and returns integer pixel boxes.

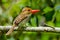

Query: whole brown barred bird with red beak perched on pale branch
[6,6,40,35]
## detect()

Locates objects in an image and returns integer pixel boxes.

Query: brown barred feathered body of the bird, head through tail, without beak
[6,8,31,35]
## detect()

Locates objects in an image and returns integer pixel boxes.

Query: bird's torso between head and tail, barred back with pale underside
[13,12,31,25]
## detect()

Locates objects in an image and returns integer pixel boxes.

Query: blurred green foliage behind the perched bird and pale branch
[0,0,60,40]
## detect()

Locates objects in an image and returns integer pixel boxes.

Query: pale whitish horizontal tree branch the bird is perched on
[0,26,60,32]
